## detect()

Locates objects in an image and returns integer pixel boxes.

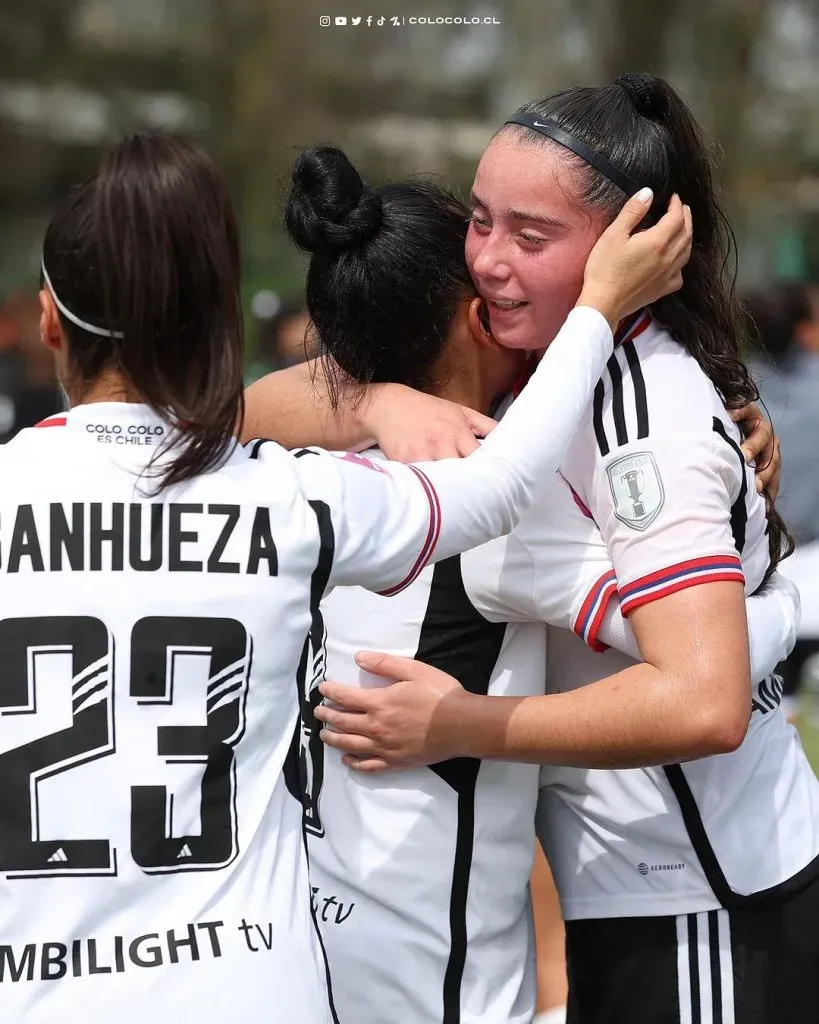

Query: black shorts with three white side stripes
[566,880,819,1024]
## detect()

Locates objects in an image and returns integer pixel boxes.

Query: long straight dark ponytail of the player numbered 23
[43,134,244,487]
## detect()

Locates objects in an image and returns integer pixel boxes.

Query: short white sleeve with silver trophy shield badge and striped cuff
[584,433,747,615]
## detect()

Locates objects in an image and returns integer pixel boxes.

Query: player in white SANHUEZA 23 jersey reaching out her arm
[0,136,690,1024]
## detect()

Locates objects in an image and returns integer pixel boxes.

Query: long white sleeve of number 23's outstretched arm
[272,307,612,594]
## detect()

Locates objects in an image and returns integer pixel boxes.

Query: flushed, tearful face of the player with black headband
[466,133,606,349]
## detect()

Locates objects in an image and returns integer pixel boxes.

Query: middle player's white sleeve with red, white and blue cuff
[461,473,616,651]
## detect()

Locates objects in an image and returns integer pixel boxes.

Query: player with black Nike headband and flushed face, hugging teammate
[305,76,819,1024]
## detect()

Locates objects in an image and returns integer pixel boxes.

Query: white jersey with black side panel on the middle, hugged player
[303,452,610,1024]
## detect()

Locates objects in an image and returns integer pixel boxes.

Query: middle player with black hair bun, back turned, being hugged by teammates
[247,147,790,1024]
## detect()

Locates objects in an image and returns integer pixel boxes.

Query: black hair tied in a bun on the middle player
[285,146,474,403]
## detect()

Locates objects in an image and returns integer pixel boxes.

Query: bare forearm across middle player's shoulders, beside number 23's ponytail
[241,359,372,451]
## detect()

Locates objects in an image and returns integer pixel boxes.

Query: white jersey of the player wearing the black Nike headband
[538,315,819,919]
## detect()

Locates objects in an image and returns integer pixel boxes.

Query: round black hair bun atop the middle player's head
[285,145,384,253]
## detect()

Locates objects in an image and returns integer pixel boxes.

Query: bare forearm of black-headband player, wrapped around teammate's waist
[450,665,749,769]
